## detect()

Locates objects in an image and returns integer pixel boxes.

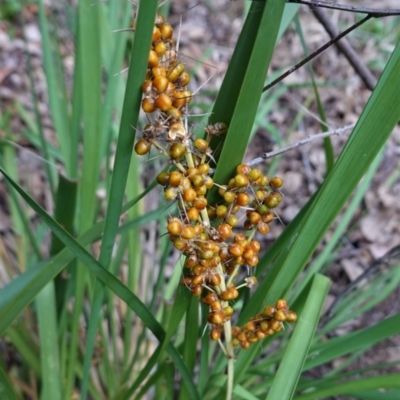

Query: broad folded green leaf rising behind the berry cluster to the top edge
[207,0,285,203]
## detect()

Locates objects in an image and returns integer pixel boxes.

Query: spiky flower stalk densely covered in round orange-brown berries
[135,7,297,398]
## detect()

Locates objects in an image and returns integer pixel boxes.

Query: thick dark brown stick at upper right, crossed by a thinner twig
[312,7,377,90]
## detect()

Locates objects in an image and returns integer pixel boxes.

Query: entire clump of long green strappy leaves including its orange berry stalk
[0,0,400,400]
